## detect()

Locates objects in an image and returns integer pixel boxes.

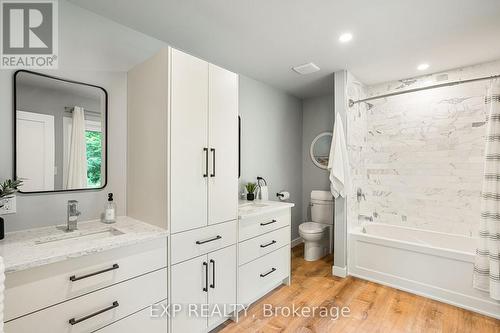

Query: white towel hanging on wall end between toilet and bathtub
[328,113,351,198]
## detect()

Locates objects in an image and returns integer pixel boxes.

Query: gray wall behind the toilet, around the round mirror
[302,95,334,221]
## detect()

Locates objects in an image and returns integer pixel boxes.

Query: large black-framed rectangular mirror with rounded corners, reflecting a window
[14,70,108,193]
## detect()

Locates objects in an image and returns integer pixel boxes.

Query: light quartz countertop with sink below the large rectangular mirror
[0,216,167,273]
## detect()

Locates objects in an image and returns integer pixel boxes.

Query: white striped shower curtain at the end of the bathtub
[474,80,500,300]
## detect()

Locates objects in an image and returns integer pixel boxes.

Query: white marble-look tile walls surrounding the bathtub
[346,61,500,235]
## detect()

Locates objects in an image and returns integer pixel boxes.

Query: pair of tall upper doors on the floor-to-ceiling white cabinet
[169,49,238,233]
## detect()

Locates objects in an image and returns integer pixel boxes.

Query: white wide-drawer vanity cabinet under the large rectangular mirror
[4,237,167,333]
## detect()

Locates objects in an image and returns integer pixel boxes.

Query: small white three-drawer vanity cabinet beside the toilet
[237,203,293,304]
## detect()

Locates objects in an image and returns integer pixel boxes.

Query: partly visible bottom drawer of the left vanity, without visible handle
[96,301,167,333]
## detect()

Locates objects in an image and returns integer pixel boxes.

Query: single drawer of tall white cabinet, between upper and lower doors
[171,221,236,265]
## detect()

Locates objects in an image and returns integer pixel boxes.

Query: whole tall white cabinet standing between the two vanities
[127,48,238,333]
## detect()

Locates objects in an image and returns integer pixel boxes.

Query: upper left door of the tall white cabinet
[172,50,209,233]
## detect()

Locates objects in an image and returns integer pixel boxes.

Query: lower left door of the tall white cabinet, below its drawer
[170,255,209,333]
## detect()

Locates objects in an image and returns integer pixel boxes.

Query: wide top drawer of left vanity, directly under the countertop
[4,238,167,321]
